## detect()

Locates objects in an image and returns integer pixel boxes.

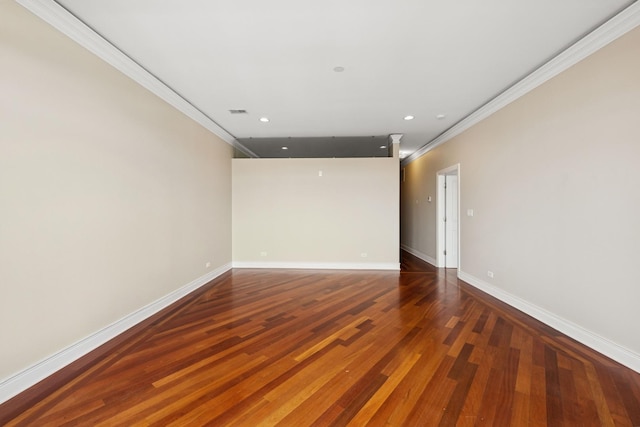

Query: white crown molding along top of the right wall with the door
[401,1,640,166]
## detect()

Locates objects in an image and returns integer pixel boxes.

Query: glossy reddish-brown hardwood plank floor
[0,254,640,427]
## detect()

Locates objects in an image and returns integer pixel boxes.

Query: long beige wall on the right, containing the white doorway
[402,29,640,360]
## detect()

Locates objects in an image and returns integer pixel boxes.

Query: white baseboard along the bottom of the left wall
[0,263,231,403]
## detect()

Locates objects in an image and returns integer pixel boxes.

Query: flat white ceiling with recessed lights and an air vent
[58,0,634,159]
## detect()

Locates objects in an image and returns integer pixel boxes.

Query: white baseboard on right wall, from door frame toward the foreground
[458,270,640,373]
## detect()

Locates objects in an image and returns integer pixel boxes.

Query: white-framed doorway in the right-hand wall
[436,164,460,268]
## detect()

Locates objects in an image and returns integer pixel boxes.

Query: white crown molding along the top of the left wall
[16,0,258,157]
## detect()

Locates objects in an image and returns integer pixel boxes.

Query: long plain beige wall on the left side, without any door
[0,0,232,380]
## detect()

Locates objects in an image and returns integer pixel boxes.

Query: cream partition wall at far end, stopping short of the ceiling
[233,158,399,269]
